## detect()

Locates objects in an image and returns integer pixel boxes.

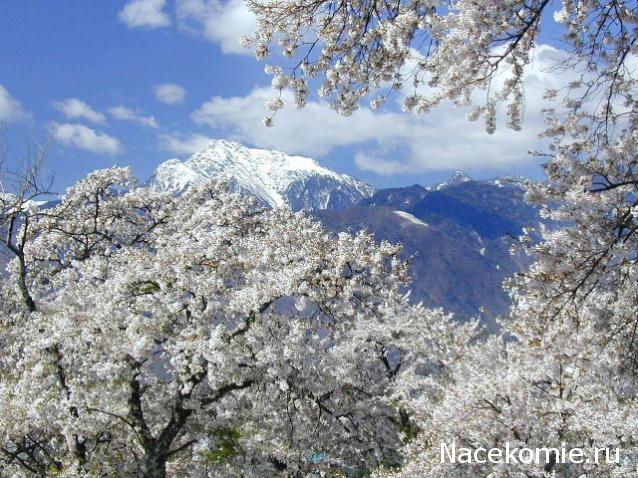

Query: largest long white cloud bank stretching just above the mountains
[191,47,567,174]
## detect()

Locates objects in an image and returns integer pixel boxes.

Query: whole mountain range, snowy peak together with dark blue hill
[0,141,540,324]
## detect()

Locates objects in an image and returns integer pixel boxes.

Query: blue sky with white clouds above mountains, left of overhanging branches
[0,0,559,190]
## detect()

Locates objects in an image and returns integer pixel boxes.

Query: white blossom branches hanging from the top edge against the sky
[248,0,638,132]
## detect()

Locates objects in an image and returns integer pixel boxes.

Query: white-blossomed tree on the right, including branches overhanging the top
[241,0,638,477]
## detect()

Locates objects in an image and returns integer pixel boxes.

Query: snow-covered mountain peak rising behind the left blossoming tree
[151,140,374,211]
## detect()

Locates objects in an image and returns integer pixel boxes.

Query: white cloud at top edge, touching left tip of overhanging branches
[177,0,256,55]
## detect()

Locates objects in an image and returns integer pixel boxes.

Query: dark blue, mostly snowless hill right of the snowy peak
[312,173,539,325]
